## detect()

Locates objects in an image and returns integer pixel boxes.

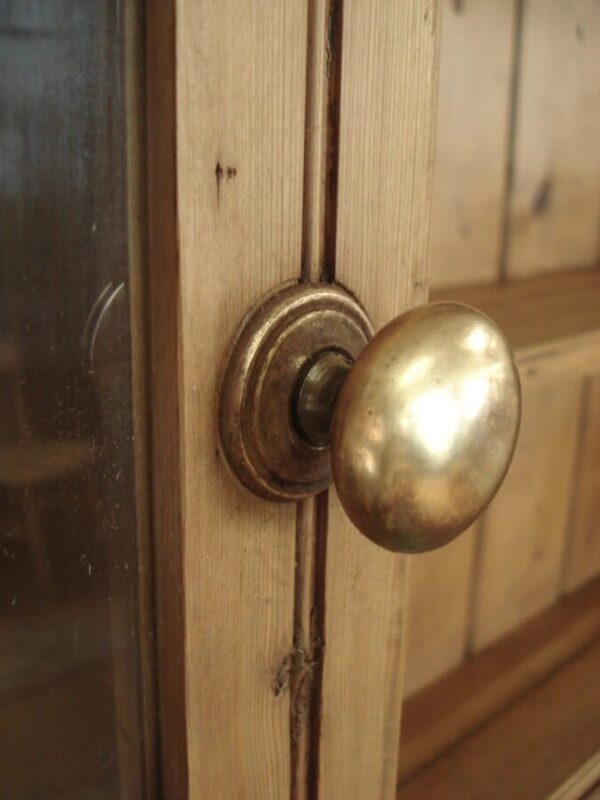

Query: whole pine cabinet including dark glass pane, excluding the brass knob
[0,0,600,800]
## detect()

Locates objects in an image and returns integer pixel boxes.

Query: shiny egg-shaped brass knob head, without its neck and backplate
[331,303,521,553]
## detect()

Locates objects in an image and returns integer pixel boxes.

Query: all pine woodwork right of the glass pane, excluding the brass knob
[148,0,600,798]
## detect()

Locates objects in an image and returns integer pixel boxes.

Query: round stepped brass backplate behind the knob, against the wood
[218,283,372,501]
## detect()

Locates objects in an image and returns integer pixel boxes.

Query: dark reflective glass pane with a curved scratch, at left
[0,0,155,800]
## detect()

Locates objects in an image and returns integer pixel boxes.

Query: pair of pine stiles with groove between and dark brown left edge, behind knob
[146,0,438,800]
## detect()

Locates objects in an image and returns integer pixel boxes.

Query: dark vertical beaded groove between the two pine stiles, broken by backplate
[288,0,343,800]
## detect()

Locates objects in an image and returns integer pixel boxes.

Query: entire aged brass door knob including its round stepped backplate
[219,284,521,552]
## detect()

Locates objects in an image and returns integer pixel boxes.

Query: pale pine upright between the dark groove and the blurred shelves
[319,0,438,800]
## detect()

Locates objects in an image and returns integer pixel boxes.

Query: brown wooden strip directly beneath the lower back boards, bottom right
[399,581,600,781]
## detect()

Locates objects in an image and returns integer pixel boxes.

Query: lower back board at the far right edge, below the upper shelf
[564,377,600,591]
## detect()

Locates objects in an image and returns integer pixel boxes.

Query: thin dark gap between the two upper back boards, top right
[498,0,524,281]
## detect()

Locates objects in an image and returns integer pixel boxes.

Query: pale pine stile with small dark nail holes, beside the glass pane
[155,0,306,800]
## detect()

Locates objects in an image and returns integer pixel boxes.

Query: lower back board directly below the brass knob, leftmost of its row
[404,524,478,697]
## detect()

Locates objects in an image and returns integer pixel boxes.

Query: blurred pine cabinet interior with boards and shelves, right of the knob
[400,0,600,798]
